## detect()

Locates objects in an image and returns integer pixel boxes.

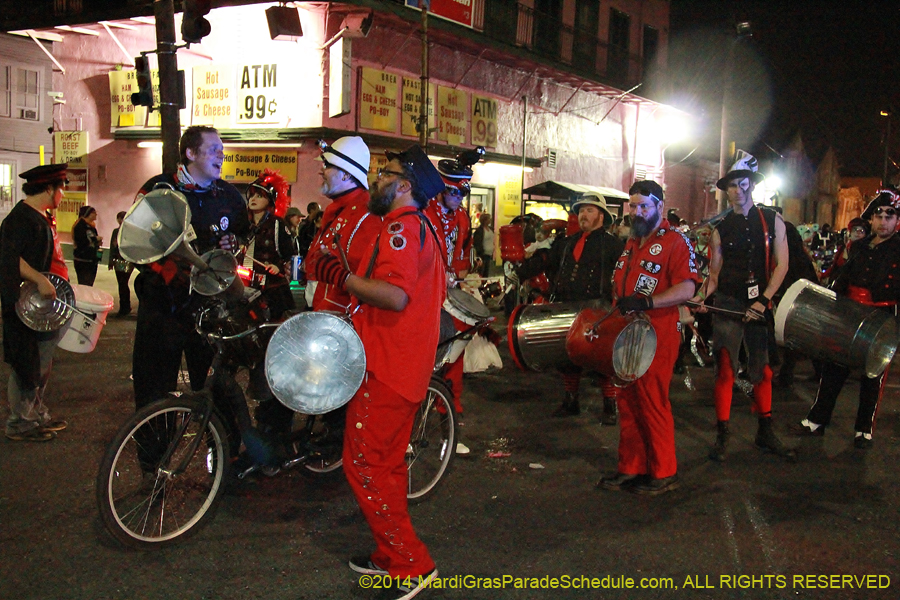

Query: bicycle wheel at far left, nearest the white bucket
[96,398,229,550]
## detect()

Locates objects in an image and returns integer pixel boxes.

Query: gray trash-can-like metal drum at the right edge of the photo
[775,279,898,377]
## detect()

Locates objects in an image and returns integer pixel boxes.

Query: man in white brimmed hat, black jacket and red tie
[518,192,623,418]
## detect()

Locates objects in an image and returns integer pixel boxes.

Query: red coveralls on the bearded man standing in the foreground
[343,208,446,577]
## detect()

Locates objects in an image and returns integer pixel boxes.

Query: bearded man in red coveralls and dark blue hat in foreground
[315,146,446,598]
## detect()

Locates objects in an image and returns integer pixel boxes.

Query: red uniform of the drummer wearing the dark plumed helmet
[425,198,472,415]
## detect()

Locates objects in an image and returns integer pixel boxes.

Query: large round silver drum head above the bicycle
[266,312,366,415]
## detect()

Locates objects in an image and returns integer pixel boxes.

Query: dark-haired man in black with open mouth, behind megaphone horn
[131,125,250,408]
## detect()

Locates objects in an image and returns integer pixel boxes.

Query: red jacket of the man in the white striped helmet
[306,187,381,312]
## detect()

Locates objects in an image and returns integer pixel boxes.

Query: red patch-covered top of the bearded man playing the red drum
[613,219,701,336]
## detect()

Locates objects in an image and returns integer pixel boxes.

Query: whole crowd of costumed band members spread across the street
[0,134,900,598]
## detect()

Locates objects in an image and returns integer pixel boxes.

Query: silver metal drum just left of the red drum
[506,300,609,371]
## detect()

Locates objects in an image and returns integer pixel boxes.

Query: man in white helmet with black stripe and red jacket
[306,136,381,311]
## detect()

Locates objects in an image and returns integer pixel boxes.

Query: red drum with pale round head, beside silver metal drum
[566,309,656,385]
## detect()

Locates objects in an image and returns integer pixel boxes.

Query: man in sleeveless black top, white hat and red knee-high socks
[694,150,795,462]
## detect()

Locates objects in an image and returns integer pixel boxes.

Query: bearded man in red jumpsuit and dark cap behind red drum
[598,180,700,496]
